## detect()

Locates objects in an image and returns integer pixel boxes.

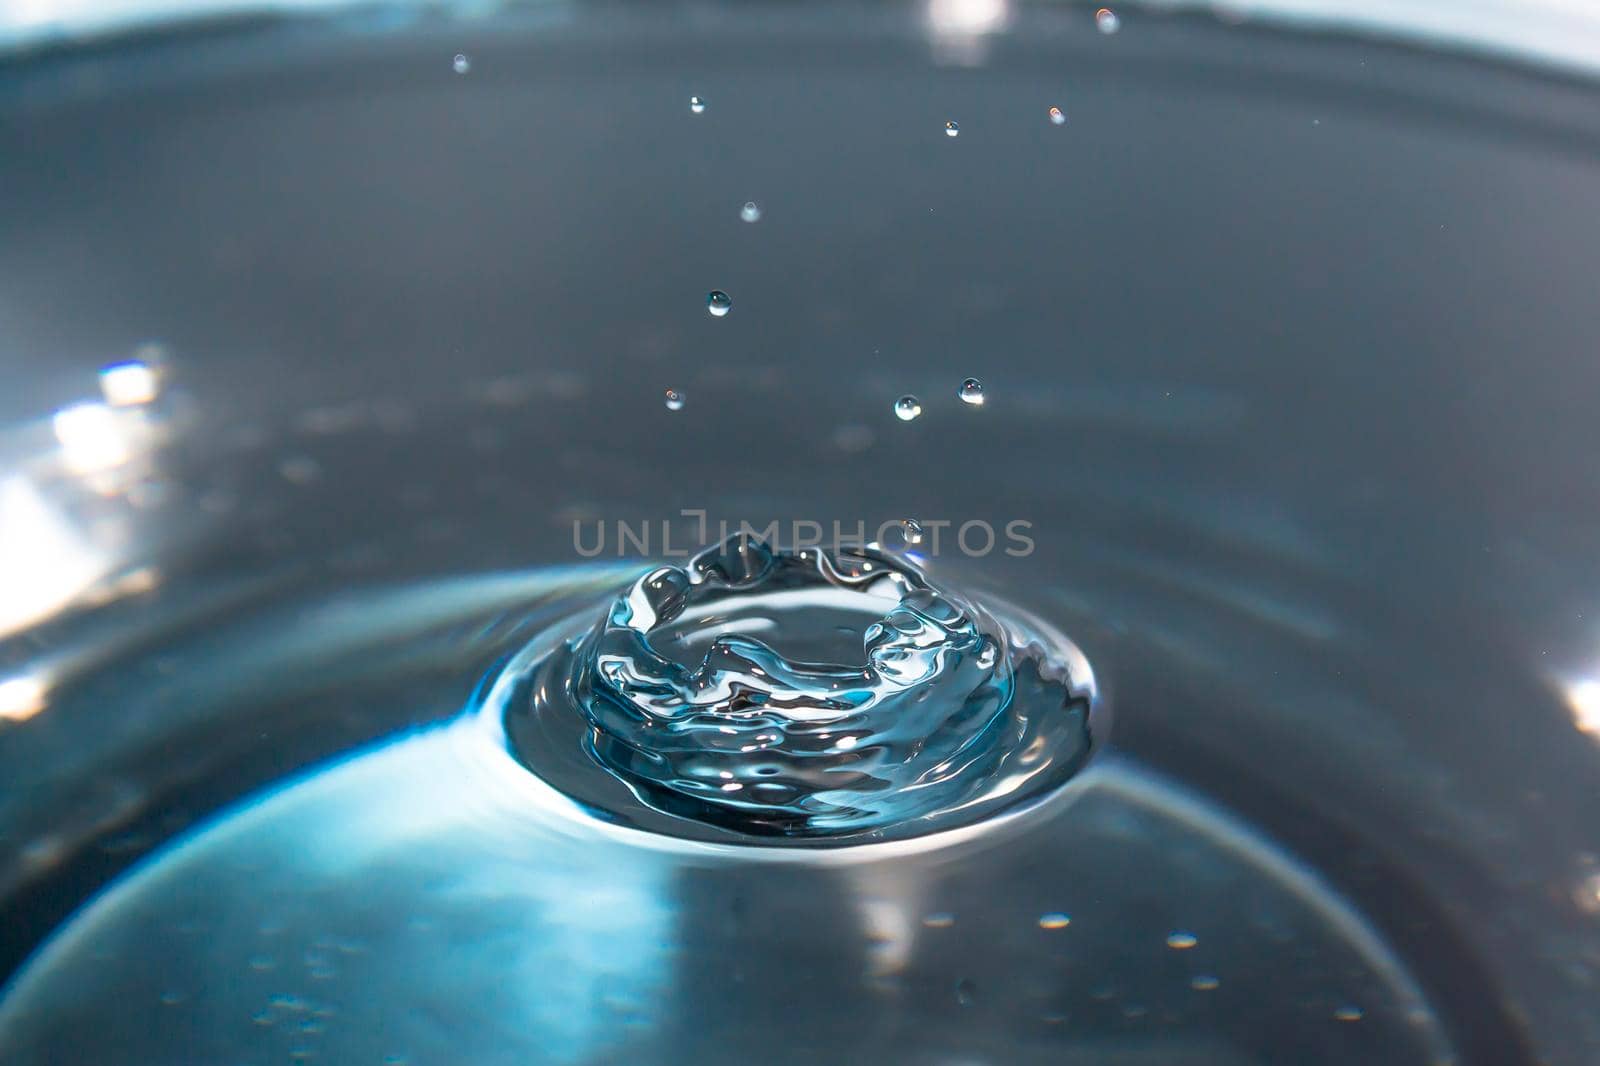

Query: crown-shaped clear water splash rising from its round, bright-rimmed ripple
[499,533,1091,844]
